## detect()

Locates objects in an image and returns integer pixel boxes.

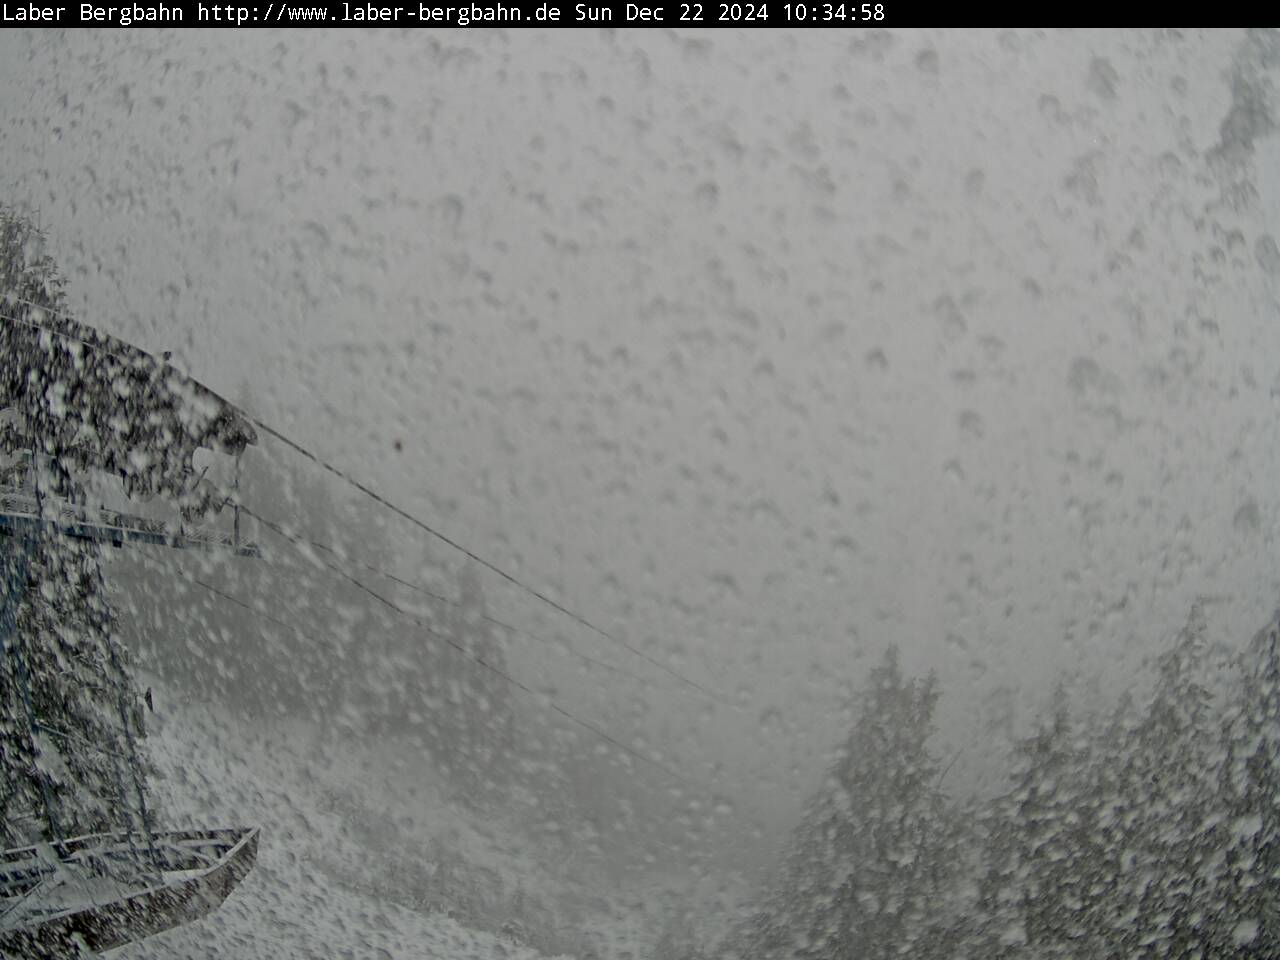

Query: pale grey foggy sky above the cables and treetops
[0,29,1280,814]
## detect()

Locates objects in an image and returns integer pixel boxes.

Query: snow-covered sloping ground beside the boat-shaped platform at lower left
[102,696,655,960]
